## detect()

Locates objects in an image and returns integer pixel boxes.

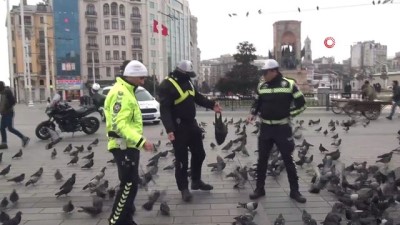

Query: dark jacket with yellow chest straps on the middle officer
[159,71,215,133]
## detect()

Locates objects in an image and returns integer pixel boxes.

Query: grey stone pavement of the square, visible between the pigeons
[0,105,400,225]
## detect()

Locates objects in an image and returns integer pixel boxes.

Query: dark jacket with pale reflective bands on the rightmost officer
[251,73,306,120]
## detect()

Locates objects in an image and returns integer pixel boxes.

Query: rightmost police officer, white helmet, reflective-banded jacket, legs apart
[248,59,306,203]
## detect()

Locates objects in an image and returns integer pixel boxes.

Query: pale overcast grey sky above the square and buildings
[0,0,400,83]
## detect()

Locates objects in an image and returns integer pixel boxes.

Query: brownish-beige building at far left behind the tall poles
[9,2,57,103]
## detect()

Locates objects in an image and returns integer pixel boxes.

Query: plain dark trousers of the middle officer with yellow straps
[172,120,206,191]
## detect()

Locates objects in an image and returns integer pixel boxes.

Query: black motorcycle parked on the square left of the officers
[35,94,100,140]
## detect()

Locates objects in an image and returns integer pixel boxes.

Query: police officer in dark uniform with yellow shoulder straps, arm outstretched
[159,60,221,202]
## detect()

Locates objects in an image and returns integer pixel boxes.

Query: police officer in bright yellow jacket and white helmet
[104,60,153,225]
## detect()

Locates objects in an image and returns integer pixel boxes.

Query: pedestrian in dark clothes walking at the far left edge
[0,81,30,149]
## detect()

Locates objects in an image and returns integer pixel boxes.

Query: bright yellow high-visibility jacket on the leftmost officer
[104,77,146,150]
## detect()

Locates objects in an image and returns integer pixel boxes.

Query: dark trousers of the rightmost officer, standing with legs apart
[257,124,299,192]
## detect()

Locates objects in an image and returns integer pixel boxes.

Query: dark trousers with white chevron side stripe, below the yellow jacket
[109,148,140,225]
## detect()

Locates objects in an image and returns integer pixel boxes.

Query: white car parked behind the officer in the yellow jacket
[101,86,161,124]
